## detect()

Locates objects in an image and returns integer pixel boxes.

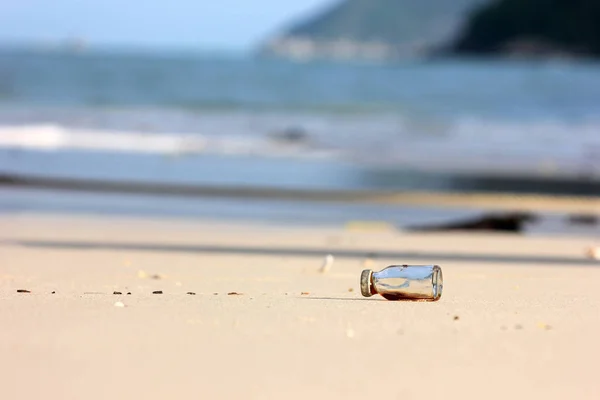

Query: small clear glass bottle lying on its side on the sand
[360,265,444,301]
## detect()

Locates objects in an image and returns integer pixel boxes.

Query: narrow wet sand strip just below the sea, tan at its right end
[0,174,600,214]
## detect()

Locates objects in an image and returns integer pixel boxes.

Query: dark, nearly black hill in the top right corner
[453,0,600,57]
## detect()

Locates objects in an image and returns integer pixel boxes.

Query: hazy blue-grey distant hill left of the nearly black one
[261,0,489,60]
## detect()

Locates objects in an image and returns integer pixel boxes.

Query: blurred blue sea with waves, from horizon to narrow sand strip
[0,49,600,194]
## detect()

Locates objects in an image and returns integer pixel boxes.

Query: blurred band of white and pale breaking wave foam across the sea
[0,118,600,180]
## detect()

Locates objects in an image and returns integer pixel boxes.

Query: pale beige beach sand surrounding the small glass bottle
[0,214,600,399]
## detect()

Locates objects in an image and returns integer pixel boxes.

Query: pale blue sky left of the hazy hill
[0,0,333,50]
